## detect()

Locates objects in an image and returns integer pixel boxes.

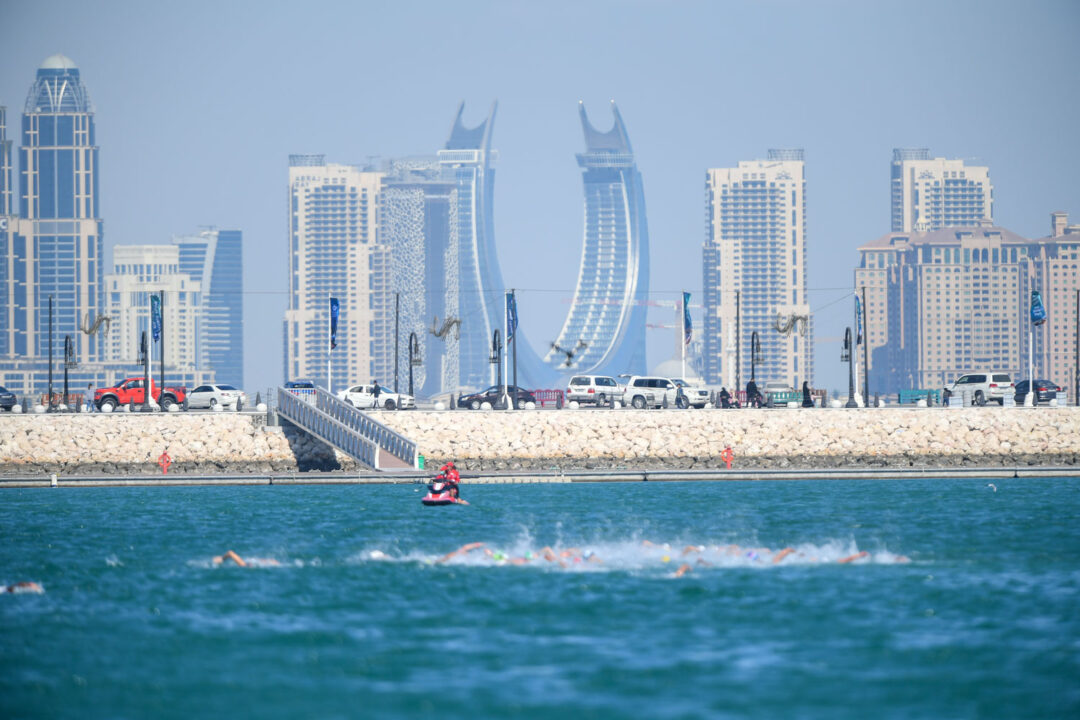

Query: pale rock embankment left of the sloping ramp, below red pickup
[0,412,355,476]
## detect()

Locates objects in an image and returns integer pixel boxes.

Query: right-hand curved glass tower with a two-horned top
[544,100,649,375]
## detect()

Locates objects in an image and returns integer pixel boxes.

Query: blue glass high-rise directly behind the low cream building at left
[173,228,244,388]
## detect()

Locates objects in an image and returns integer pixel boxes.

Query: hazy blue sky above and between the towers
[0,0,1080,390]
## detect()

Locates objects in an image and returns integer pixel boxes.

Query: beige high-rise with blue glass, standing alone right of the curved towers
[702,150,813,388]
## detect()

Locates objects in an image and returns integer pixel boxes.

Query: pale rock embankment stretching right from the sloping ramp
[379,407,1080,471]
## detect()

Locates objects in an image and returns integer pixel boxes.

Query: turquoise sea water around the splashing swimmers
[0,478,1080,720]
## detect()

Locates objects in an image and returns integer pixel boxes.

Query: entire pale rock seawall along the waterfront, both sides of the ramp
[0,407,1080,476]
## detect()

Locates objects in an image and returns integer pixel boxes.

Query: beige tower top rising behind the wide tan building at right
[891,148,994,232]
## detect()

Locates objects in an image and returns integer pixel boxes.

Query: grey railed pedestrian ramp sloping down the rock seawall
[278,388,418,471]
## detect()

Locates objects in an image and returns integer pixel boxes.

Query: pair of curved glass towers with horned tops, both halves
[447,100,649,388]
